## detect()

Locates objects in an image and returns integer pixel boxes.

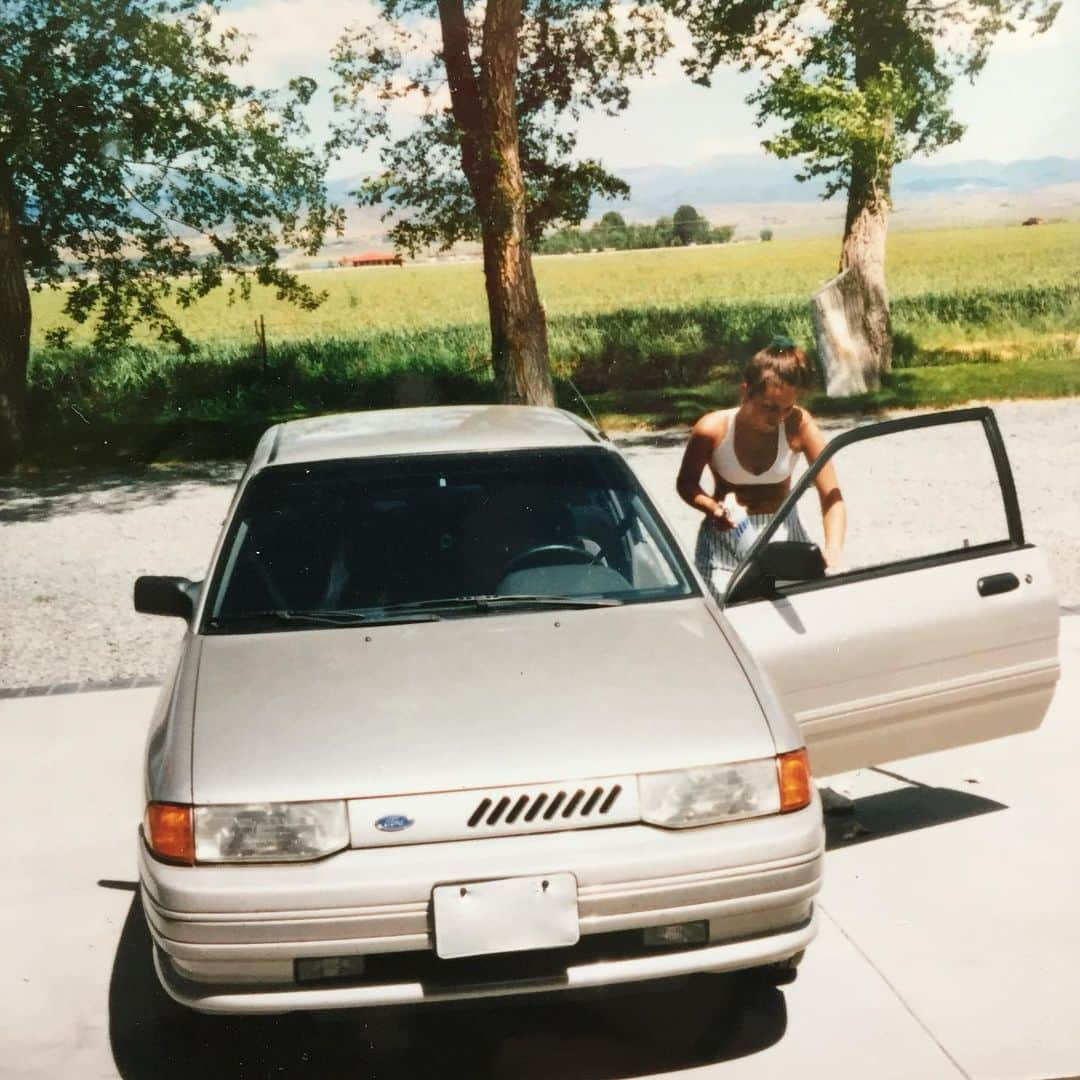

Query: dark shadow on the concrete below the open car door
[825,784,1009,851]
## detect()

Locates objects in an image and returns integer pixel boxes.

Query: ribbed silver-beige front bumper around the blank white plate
[140,798,824,1013]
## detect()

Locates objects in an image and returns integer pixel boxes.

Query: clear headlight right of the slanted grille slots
[637,757,780,828]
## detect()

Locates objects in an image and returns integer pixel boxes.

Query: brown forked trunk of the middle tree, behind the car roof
[438,0,555,405]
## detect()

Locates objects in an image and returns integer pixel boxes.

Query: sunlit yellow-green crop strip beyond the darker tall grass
[25,221,1080,346]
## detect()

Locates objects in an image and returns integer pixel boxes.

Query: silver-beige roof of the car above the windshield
[252,405,604,469]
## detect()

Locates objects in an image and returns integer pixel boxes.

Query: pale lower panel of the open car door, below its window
[725,548,1058,775]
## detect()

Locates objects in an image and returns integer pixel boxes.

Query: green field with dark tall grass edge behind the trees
[30,222,1080,457]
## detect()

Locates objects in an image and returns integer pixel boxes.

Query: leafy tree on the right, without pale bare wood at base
[663,0,1061,384]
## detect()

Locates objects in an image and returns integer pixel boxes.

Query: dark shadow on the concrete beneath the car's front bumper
[109,894,787,1080]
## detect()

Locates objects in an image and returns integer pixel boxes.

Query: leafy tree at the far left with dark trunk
[0,0,338,467]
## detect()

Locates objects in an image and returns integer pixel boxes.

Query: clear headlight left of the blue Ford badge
[194,802,349,863]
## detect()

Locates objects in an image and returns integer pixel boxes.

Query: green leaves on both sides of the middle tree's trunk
[333,0,671,254]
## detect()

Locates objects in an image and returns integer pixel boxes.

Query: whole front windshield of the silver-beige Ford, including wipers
[203,448,697,633]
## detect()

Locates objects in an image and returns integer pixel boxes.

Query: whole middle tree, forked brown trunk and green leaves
[335,0,669,404]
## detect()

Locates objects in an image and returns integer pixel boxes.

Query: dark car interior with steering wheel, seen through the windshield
[212,453,679,618]
